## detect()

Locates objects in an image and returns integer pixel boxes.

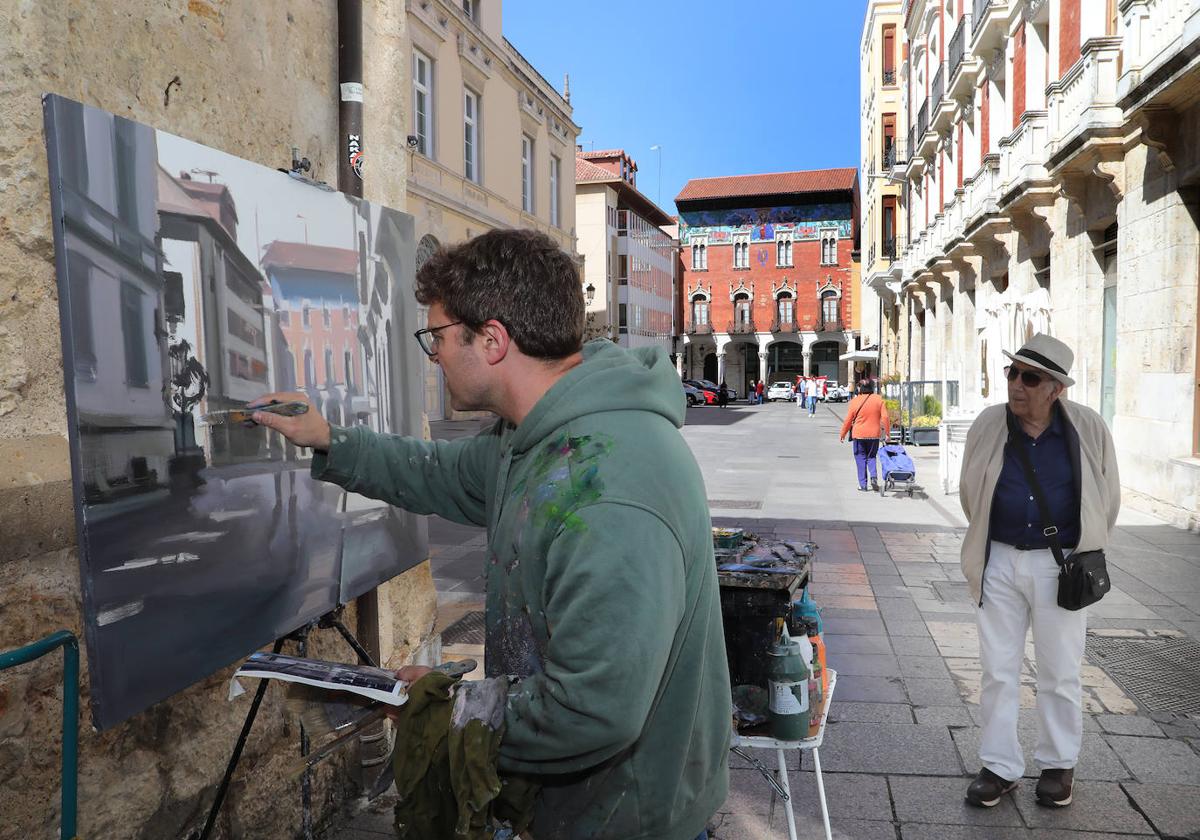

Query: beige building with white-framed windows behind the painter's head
[404,0,580,420]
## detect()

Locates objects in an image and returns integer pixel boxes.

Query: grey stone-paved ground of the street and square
[330,403,1200,840]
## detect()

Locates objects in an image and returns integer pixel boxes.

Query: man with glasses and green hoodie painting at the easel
[254,230,731,840]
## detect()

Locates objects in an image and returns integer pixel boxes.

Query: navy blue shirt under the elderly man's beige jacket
[991,404,1079,548]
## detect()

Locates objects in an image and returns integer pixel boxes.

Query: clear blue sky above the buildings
[503,0,866,214]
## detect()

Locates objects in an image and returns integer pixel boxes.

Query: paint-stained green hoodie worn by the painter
[312,340,731,840]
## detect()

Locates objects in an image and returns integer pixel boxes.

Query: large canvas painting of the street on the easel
[44,96,427,728]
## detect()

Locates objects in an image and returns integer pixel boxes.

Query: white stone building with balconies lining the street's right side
[886,0,1200,527]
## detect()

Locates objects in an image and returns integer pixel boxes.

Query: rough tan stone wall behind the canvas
[0,0,436,840]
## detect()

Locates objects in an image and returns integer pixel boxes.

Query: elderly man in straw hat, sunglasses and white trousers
[959,334,1121,808]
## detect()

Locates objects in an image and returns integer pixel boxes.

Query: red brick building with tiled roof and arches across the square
[676,168,858,394]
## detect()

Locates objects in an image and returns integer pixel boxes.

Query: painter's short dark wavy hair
[416,230,583,359]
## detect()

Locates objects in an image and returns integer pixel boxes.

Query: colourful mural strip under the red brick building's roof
[679,202,853,244]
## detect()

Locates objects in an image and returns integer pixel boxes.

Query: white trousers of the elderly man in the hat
[978,541,1087,780]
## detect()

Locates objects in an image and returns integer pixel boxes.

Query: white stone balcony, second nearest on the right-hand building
[1046,38,1124,169]
